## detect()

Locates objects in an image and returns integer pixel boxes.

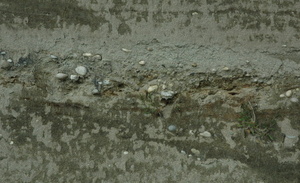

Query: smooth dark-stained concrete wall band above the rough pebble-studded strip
[0,0,300,49]
